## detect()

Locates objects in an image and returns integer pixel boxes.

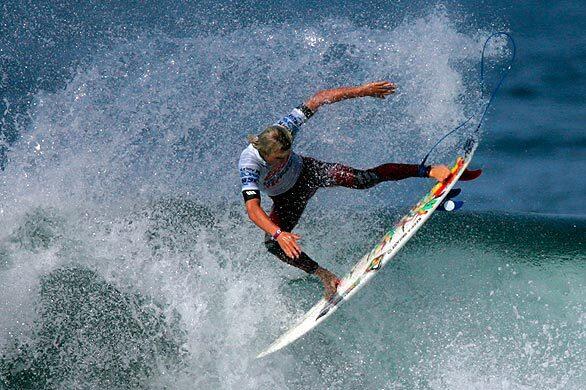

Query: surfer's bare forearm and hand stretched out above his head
[304,81,396,112]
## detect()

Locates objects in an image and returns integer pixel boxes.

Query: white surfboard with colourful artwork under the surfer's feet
[257,138,478,358]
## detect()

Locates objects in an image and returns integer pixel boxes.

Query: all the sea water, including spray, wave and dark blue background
[0,1,586,390]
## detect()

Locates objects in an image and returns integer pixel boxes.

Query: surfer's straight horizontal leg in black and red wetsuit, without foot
[321,163,419,189]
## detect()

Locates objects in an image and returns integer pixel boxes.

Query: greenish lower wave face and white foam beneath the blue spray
[0,199,586,388]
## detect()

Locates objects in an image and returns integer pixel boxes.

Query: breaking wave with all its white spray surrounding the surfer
[0,3,585,389]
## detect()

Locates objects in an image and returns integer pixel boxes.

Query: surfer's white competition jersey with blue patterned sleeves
[238,108,308,196]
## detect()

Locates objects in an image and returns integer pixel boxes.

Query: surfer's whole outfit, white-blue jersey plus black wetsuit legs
[238,105,429,273]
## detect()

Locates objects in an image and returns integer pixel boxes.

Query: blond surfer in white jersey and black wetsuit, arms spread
[238,81,450,298]
